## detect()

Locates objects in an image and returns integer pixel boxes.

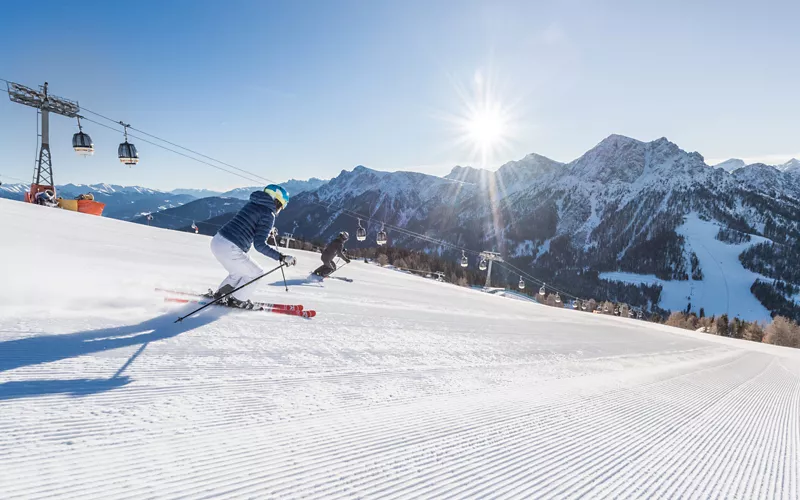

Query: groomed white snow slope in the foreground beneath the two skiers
[0,200,800,499]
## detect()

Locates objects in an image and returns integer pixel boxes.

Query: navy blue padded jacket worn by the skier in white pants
[218,191,281,260]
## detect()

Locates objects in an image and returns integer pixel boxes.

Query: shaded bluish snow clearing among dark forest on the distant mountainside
[600,214,770,321]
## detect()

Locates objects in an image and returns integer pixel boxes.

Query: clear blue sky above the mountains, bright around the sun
[0,0,800,189]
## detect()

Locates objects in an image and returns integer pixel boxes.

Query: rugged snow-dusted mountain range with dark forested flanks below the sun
[281,135,800,316]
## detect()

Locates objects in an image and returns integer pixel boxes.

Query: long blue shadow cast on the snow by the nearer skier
[0,307,226,401]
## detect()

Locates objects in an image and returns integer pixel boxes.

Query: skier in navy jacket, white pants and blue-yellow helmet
[211,184,296,309]
